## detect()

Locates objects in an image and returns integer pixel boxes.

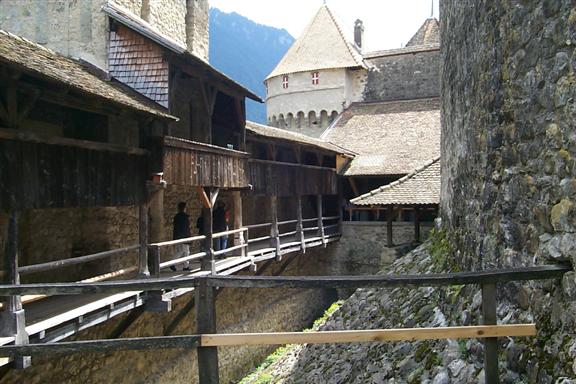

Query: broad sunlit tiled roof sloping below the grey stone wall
[321,98,440,176]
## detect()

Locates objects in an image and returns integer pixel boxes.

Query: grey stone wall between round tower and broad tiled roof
[363,50,440,101]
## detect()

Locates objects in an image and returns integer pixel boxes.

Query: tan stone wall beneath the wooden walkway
[0,246,335,384]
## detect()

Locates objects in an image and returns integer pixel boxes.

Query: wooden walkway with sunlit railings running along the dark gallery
[0,210,340,367]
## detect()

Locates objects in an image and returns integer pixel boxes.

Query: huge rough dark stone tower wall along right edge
[440,0,576,383]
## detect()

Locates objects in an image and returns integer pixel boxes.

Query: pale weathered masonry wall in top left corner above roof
[0,0,108,70]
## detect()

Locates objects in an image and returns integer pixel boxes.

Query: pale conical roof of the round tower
[267,5,365,79]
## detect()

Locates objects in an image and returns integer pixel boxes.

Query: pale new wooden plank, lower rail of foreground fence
[200,324,536,347]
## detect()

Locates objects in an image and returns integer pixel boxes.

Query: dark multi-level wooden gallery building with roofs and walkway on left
[0,11,352,374]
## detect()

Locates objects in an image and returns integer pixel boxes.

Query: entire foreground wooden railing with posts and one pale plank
[0,265,571,384]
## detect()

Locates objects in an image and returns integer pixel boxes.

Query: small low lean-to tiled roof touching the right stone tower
[350,158,440,206]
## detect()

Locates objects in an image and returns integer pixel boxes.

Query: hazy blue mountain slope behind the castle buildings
[210,8,294,124]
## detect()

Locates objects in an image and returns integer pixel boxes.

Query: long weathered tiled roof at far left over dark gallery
[0,30,177,120]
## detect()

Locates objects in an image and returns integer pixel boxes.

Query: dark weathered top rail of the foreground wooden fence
[0,264,572,296]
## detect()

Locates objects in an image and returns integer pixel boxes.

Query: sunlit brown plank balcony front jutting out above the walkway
[163,137,249,188]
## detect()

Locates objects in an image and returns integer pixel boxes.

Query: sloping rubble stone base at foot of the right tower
[238,234,576,384]
